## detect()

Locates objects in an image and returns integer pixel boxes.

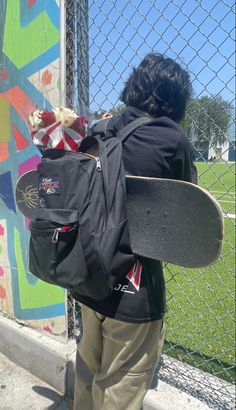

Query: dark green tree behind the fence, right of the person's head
[181,96,231,147]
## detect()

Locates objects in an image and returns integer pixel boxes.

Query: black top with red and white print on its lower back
[73,107,196,323]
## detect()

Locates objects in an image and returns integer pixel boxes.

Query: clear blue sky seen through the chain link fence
[89,0,235,111]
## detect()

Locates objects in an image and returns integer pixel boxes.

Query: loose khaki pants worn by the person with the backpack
[74,305,164,410]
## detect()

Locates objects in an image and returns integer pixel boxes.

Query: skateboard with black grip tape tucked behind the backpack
[16,171,223,268]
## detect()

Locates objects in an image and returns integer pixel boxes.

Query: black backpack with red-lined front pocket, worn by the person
[29,117,150,300]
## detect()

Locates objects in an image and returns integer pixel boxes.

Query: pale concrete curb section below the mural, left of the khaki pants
[0,316,76,398]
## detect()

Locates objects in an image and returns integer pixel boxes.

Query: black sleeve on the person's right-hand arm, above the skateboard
[172,136,198,184]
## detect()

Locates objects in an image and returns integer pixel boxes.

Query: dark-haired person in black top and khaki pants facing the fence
[73,54,194,410]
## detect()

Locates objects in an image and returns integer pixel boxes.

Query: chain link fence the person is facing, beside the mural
[66,0,236,409]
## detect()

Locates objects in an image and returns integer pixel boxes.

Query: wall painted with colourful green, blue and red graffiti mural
[0,0,67,337]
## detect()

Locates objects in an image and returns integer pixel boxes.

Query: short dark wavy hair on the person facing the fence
[120,53,192,122]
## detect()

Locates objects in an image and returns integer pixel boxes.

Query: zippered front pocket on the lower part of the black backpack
[29,209,87,291]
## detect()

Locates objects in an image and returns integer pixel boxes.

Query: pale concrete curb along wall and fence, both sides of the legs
[0,314,231,410]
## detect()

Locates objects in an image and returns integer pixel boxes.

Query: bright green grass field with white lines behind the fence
[164,163,235,382]
